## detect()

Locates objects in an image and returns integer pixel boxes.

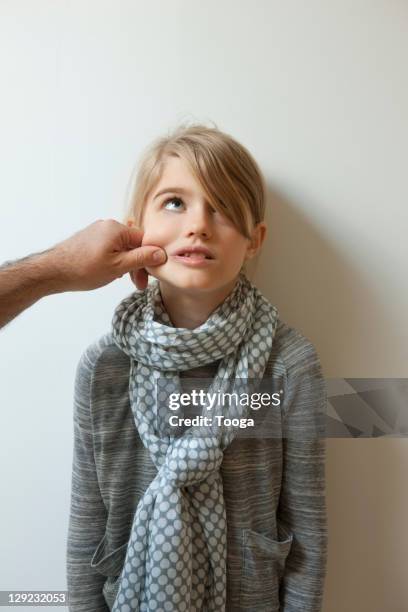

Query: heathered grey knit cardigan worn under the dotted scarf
[66,321,327,612]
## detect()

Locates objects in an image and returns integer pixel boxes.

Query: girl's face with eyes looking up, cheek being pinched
[135,157,266,291]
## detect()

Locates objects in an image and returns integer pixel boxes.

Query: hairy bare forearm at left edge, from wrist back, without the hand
[0,248,64,328]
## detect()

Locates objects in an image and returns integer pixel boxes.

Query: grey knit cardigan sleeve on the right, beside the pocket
[278,334,328,612]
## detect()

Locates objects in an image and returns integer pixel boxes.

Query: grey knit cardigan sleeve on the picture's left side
[66,349,109,612]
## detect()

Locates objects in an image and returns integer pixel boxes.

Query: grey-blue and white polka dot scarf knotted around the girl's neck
[112,272,278,612]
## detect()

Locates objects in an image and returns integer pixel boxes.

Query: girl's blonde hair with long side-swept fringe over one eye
[124,123,266,267]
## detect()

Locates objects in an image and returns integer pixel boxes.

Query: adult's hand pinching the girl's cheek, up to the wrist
[53,219,167,291]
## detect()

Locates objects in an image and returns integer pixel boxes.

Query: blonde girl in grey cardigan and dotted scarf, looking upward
[67,125,327,612]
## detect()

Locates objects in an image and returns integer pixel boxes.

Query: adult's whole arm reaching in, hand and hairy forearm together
[0,219,167,328]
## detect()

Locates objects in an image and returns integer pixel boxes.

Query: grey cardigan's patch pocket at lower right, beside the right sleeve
[240,526,293,612]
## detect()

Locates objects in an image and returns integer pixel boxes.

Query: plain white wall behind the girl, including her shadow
[0,0,408,612]
